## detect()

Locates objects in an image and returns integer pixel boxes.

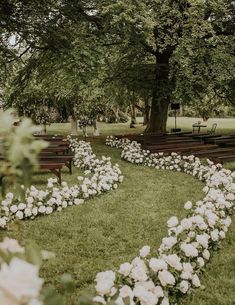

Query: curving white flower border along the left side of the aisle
[0,139,123,228]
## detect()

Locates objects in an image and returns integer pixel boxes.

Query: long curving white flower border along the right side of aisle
[92,137,235,305]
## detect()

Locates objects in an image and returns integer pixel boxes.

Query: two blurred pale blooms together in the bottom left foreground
[0,237,43,305]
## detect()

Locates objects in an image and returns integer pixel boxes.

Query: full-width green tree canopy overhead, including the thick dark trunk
[0,0,235,133]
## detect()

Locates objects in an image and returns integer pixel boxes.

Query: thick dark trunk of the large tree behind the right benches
[145,52,172,134]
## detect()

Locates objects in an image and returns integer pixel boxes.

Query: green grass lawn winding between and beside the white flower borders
[0,120,235,305]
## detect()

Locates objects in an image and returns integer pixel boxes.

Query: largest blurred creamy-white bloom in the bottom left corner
[0,257,43,304]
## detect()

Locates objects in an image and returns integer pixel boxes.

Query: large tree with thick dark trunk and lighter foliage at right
[96,0,234,133]
